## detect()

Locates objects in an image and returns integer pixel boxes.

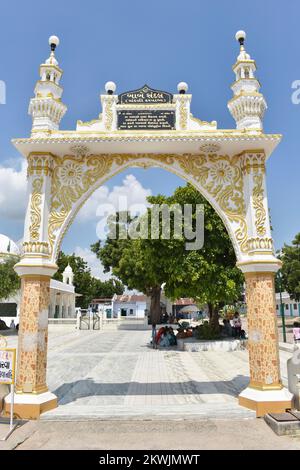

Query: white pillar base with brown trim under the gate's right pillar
[239,387,293,418]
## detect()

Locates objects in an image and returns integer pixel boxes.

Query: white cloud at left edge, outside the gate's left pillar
[0,160,27,220]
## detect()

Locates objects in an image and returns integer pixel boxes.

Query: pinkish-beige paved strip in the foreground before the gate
[0,419,300,452]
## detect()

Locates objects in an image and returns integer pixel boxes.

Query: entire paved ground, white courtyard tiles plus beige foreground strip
[0,327,300,450]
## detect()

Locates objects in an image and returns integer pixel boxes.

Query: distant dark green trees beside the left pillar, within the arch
[53,252,124,308]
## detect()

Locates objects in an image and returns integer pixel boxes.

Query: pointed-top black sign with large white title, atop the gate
[118,85,173,104]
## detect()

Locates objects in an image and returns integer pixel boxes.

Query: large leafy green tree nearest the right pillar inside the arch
[148,184,244,328]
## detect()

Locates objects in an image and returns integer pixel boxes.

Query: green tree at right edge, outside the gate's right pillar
[281,233,300,301]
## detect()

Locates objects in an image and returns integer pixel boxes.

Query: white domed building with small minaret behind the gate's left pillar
[0,234,77,326]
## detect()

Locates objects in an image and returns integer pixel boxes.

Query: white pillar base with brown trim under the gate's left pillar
[4,392,58,419]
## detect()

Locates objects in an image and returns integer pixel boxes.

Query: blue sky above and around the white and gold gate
[0,0,300,272]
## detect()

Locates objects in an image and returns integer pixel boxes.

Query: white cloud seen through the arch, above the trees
[77,175,152,222]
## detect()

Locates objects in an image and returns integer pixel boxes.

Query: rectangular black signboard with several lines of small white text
[118,109,175,130]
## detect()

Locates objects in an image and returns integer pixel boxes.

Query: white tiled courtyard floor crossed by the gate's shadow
[1,326,289,420]
